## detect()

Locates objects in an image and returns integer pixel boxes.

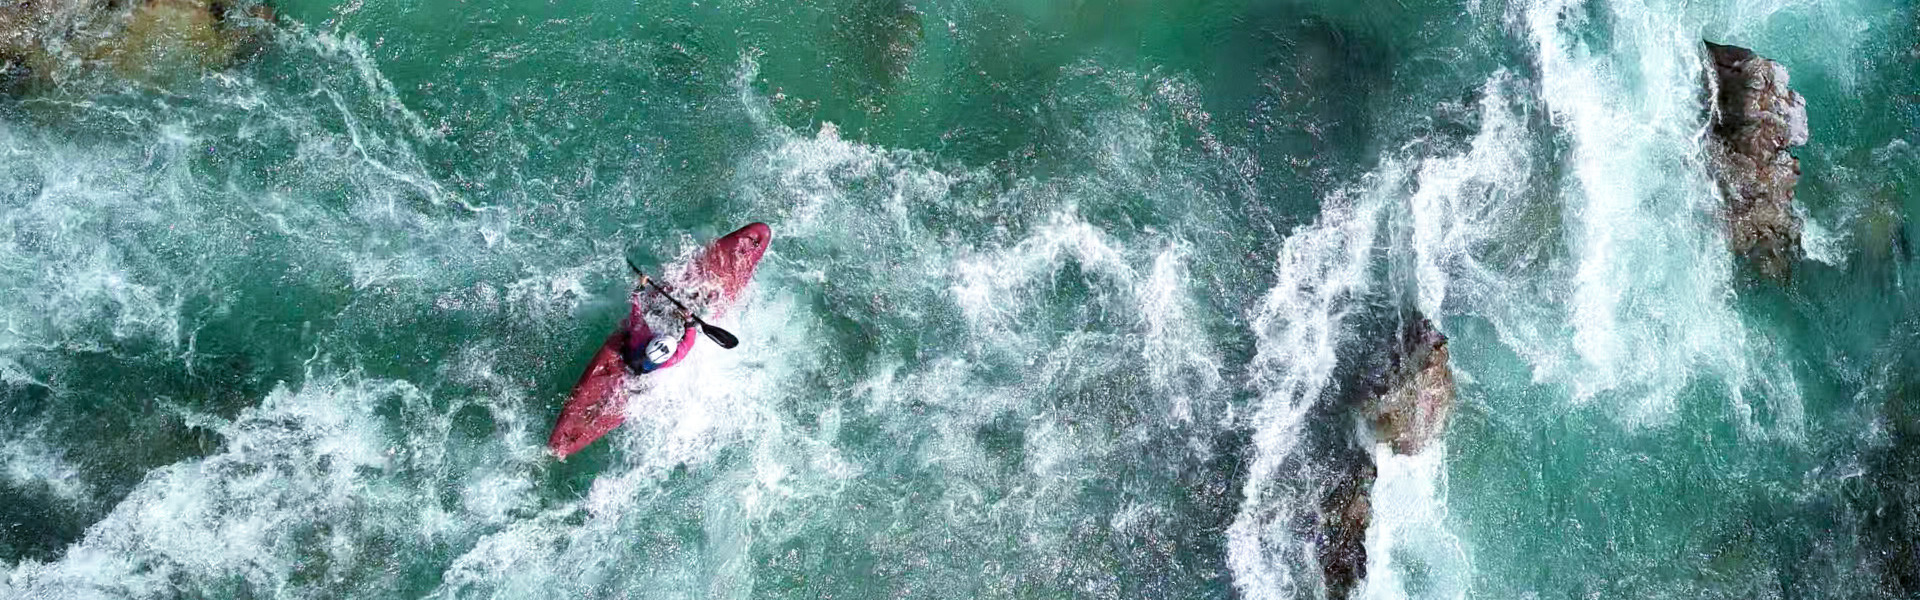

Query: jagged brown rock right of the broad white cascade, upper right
[1707,42,1807,279]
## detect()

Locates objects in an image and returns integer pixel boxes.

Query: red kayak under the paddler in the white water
[547,223,774,460]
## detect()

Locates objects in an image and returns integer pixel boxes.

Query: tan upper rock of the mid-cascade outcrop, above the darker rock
[1365,317,1453,454]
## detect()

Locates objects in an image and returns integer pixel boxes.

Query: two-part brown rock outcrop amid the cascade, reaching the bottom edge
[1315,315,1453,600]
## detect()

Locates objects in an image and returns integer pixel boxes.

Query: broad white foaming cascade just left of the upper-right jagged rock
[1497,2,1799,425]
